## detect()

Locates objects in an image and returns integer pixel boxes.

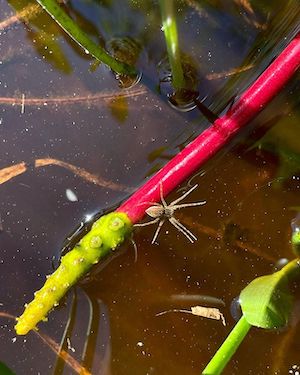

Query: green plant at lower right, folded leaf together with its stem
[202,225,300,375]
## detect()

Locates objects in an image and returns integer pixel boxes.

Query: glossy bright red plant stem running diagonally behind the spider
[117,34,300,223]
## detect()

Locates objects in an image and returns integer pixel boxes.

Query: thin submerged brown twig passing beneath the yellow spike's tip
[0,311,91,375]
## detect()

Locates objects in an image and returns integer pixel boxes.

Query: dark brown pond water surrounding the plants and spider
[0,0,300,375]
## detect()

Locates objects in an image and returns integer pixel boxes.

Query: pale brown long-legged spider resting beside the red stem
[135,183,206,244]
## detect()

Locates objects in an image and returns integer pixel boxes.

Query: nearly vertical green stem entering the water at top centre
[159,0,185,90]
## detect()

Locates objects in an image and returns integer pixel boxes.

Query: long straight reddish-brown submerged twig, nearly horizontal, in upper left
[0,86,147,108]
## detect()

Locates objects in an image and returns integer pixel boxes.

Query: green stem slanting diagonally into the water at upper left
[36,0,137,76]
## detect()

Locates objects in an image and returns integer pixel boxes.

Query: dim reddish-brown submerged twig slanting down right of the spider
[178,213,277,263]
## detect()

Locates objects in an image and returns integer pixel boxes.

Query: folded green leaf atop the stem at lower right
[240,259,300,329]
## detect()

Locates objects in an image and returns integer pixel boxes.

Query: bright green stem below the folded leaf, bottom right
[202,316,251,375]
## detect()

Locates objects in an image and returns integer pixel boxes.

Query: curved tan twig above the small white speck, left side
[0,158,133,193]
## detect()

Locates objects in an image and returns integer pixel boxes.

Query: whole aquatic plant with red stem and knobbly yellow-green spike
[16,28,300,334]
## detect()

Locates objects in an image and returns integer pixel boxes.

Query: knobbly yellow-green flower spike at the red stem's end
[15,212,132,335]
